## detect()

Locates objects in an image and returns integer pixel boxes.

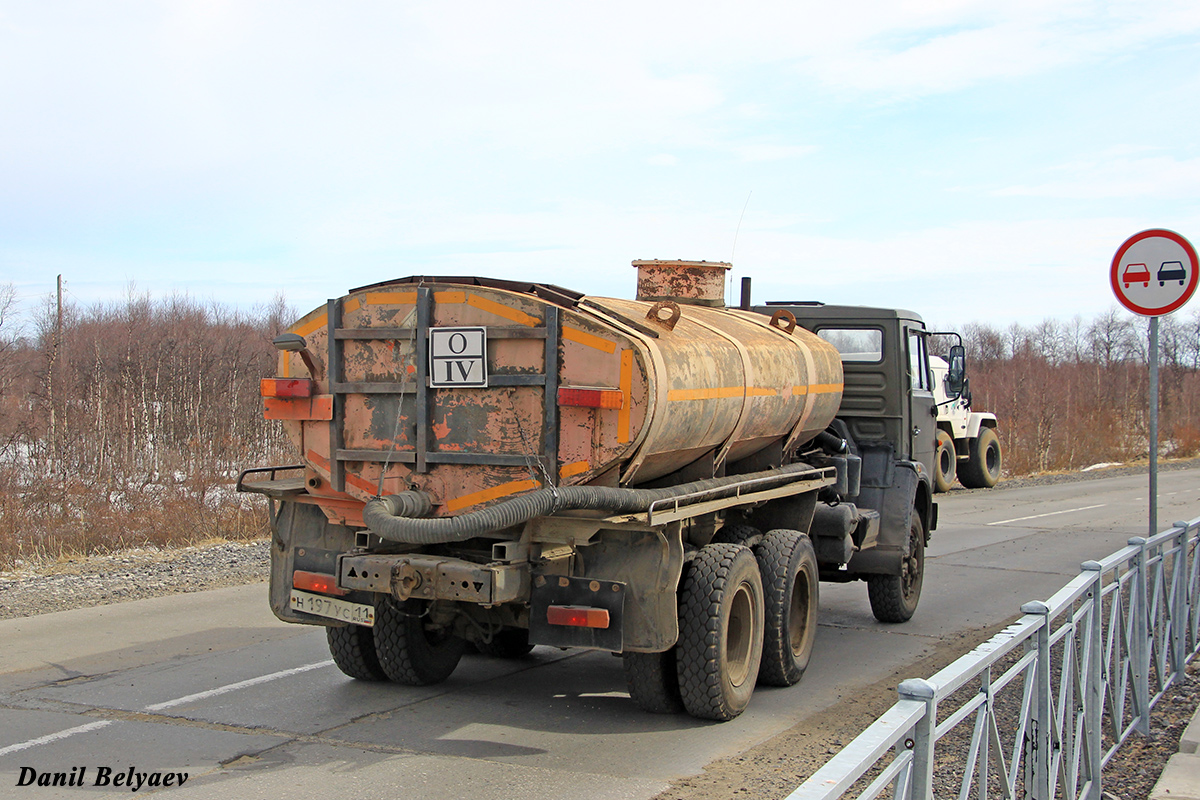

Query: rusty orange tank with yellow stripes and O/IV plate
[264,261,842,525]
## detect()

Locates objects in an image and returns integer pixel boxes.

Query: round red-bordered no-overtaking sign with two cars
[1109,228,1200,317]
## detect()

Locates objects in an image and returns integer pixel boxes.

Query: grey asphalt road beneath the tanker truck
[0,469,1200,800]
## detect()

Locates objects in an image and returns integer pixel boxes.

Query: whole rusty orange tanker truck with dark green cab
[238,261,953,720]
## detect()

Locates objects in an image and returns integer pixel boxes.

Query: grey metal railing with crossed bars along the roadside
[788,517,1200,800]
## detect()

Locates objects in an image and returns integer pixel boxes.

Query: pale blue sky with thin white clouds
[0,0,1200,325]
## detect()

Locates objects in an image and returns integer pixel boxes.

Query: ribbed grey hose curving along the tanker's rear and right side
[362,463,812,545]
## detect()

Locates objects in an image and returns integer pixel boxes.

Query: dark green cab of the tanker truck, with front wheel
[756,302,937,622]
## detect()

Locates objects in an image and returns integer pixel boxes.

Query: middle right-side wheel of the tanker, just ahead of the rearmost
[754,530,820,686]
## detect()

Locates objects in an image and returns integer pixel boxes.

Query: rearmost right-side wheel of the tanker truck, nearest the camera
[676,543,763,722]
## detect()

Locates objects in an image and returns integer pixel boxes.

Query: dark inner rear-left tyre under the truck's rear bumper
[374,597,467,686]
